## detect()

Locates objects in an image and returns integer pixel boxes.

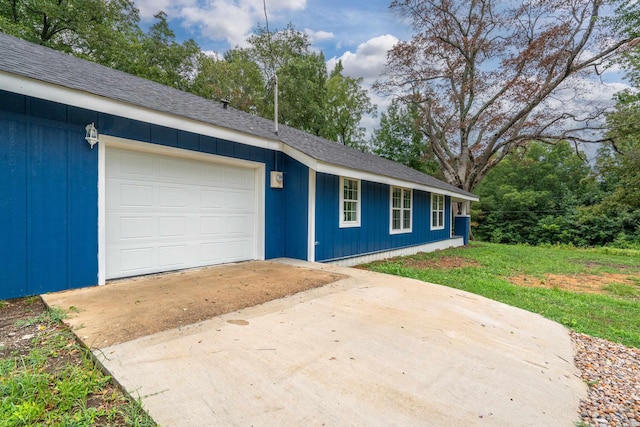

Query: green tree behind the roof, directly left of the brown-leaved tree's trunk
[370,99,442,178]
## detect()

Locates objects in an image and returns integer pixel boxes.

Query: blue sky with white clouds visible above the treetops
[134,0,625,143]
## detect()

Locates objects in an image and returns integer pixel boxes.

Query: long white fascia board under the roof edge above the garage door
[0,71,283,151]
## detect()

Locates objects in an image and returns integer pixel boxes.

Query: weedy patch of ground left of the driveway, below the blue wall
[0,297,155,427]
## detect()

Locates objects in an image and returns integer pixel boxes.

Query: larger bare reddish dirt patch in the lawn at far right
[509,273,636,294]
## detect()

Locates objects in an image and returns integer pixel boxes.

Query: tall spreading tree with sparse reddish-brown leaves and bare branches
[377,0,632,191]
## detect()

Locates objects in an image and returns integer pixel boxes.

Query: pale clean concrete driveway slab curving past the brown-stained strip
[45,260,587,426]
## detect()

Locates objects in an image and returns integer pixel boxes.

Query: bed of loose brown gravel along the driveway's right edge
[570,332,640,427]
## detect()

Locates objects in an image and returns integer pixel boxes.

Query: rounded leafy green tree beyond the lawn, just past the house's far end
[474,141,597,244]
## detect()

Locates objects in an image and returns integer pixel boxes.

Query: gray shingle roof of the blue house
[0,33,476,198]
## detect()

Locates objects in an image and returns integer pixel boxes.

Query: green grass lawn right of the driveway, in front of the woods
[363,243,640,347]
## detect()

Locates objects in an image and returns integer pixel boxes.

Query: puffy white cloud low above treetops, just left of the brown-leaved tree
[327,34,398,82]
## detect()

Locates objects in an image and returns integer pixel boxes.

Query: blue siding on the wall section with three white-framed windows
[315,173,451,262]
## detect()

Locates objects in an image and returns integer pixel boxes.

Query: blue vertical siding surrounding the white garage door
[0,91,309,299]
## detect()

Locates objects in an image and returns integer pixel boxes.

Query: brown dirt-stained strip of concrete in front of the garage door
[43,261,347,348]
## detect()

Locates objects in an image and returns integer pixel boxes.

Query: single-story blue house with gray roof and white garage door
[0,34,477,299]
